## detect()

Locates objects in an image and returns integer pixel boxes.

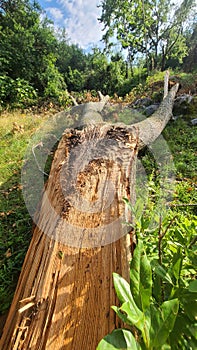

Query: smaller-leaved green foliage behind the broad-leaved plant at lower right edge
[132,204,197,349]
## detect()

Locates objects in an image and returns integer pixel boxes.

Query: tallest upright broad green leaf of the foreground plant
[130,240,152,311]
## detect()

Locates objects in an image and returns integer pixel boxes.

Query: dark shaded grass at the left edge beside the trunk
[0,171,32,333]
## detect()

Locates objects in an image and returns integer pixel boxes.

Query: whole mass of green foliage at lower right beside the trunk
[98,204,197,350]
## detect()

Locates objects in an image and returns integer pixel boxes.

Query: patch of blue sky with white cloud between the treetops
[38,0,103,49]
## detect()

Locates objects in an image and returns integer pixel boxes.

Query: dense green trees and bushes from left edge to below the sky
[0,0,130,104]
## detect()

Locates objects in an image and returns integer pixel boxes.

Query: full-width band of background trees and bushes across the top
[0,0,196,110]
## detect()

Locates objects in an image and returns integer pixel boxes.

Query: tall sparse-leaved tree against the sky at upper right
[100,0,195,70]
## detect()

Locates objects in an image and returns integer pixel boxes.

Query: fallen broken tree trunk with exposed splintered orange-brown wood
[0,79,178,350]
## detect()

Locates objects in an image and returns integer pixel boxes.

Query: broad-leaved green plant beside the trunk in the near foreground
[97,240,179,350]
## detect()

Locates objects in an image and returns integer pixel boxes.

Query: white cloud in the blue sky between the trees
[58,0,103,48]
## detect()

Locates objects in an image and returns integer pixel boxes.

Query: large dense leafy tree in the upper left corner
[0,0,64,102]
